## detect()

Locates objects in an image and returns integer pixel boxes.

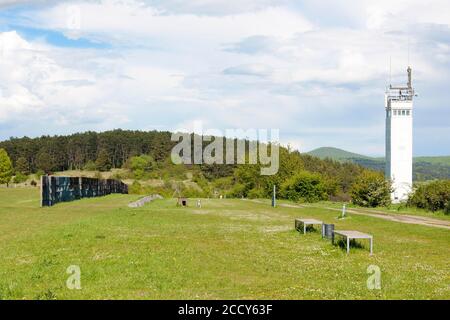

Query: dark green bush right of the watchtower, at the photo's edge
[407,180,450,214]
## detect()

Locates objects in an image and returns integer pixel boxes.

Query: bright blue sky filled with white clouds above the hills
[0,0,450,156]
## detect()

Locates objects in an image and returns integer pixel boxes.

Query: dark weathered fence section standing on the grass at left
[41,176,128,207]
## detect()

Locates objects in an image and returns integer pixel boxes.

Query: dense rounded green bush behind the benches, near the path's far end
[280,171,328,202]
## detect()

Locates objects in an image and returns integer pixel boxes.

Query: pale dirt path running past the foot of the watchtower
[280,204,450,230]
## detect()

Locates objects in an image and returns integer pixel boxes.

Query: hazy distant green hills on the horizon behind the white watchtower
[308,147,450,181]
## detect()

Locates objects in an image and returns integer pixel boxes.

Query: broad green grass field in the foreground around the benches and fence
[0,188,450,299]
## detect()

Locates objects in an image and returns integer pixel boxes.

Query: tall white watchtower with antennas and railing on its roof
[385,67,414,203]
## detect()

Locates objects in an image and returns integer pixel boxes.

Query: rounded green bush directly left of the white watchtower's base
[350,171,392,207]
